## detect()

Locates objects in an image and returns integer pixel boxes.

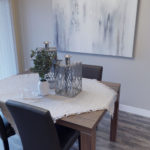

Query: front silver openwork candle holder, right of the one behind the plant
[55,57,82,97]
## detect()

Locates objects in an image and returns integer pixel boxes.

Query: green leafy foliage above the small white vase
[31,48,52,81]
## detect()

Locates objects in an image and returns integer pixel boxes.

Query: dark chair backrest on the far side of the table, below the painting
[82,64,103,81]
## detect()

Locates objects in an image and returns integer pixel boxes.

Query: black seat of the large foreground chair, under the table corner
[56,125,80,150]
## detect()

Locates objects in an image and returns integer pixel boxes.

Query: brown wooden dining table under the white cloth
[0,76,121,150]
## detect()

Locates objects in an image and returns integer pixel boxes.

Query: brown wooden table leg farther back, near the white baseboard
[110,94,119,142]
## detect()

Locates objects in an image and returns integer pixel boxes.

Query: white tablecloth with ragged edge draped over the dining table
[0,74,117,125]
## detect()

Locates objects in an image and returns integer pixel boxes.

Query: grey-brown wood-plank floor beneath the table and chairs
[0,111,150,150]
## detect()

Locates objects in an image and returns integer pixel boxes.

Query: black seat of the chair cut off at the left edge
[0,112,15,137]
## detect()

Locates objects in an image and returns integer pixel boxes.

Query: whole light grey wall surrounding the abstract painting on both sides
[16,0,150,110]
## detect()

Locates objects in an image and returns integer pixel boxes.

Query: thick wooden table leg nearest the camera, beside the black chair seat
[80,129,96,150]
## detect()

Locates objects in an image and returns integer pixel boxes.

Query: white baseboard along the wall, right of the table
[119,104,150,118]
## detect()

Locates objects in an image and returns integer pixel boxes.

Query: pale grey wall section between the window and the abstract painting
[16,0,53,70]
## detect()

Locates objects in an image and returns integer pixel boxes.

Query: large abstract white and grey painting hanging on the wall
[52,0,138,57]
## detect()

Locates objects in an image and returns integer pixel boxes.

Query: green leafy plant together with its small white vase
[31,48,52,96]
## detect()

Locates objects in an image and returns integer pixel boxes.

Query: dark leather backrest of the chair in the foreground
[6,100,60,150]
